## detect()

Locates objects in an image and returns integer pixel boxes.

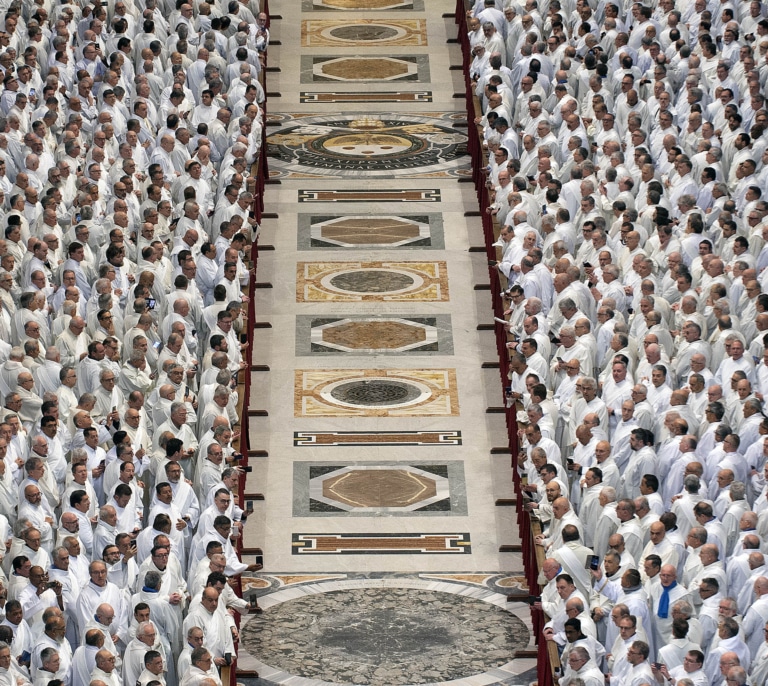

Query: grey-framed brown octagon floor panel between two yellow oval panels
[296,315,453,355]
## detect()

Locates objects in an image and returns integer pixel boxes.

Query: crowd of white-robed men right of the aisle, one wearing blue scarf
[467,0,768,686]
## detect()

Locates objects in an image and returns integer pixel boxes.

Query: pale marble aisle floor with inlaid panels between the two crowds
[244,0,535,686]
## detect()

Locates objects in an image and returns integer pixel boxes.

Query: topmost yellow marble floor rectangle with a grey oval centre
[301,19,427,48]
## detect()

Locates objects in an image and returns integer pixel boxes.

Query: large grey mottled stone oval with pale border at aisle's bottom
[241,582,530,686]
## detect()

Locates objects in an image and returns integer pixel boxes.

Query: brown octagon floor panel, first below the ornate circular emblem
[298,213,445,250]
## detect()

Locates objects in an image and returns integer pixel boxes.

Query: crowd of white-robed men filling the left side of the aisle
[0,0,269,686]
